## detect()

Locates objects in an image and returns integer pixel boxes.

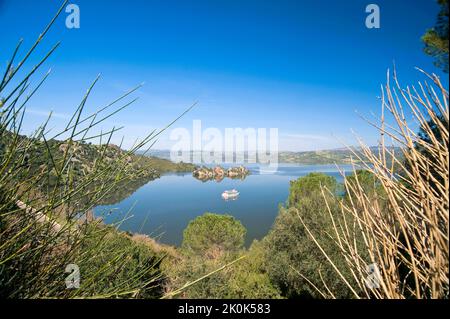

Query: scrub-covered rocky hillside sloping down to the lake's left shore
[0,132,195,204]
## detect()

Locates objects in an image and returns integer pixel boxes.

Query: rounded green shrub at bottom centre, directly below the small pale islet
[163,213,279,298]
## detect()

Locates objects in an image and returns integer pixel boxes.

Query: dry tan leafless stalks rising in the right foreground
[299,70,449,299]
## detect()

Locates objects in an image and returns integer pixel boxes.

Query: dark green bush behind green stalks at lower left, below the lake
[73,225,165,298]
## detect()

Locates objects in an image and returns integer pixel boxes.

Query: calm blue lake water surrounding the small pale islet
[94,164,351,246]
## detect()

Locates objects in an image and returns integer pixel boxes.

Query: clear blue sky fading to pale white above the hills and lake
[0,0,448,151]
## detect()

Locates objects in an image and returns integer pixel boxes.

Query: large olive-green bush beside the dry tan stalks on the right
[262,173,350,298]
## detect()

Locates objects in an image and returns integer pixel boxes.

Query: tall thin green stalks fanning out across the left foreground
[0,1,190,298]
